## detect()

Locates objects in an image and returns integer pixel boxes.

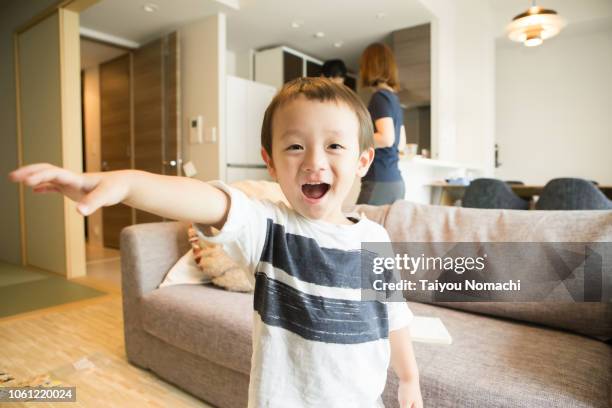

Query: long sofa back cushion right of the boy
[372,200,612,340]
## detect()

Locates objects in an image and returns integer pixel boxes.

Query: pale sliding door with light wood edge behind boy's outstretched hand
[15,9,85,278]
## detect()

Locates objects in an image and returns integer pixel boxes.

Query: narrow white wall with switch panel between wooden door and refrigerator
[179,14,227,180]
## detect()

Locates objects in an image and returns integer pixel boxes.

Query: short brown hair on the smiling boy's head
[261,78,374,157]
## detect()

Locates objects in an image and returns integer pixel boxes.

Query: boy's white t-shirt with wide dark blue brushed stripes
[199,181,412,408]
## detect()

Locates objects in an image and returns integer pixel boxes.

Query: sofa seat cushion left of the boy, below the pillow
[141,285,253,375]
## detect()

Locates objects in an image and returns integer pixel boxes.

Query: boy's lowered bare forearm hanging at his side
[389,327,423,408]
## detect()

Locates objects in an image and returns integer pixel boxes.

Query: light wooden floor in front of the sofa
[0,244,212,408]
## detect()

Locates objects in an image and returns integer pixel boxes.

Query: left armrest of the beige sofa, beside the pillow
[120,222,189,299]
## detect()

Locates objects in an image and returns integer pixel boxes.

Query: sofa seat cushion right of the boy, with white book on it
[384,302,612,408]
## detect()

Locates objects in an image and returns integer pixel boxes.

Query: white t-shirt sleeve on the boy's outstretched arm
[194,180,276,274]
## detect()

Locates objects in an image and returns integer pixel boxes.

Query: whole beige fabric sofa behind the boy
[121,201,612,408]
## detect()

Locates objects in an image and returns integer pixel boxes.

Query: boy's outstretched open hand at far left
[9,163,129,215]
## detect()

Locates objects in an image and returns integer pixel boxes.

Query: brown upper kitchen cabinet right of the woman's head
[392,24,431,109]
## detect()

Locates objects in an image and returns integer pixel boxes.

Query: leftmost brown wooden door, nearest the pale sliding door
[100,54,132,248]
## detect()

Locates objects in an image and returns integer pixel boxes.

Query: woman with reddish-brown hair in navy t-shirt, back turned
[357,43,406,205]
